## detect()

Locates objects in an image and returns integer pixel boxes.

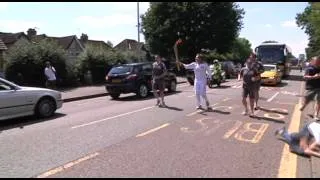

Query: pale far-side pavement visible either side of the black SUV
[60,77,187,102]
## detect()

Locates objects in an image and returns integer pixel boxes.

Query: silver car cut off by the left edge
[0,78,63,120]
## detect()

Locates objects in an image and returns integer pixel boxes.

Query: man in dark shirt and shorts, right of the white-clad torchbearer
[238,58,258,117]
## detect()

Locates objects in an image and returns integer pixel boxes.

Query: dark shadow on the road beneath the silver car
[0,113,66,133]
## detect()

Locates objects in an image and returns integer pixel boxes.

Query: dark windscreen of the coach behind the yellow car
[258,46,285,64]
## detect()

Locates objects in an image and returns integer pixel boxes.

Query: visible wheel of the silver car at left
[36,98,56,118]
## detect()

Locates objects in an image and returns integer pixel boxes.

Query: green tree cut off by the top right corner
[296,2,320,59]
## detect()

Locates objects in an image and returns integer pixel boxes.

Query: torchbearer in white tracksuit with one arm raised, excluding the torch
[177,53,212,110]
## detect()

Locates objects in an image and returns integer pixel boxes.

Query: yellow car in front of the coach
[261,64,282,85]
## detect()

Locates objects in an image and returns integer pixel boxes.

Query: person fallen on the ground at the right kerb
[275,122,320,157]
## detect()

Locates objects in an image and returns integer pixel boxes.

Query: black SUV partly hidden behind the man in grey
[105,62,177,99]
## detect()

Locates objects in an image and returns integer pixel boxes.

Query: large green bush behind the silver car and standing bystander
[5,39,72,86]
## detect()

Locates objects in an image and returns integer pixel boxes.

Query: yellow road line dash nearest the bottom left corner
[36,152,99,178]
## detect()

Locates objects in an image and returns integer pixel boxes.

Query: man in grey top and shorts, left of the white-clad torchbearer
[152,55,167,107]
